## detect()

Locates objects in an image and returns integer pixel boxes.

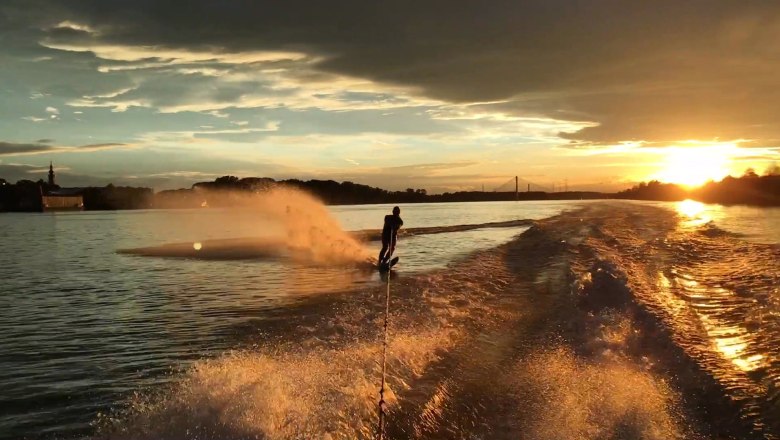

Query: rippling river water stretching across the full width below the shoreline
[0,202,780,439]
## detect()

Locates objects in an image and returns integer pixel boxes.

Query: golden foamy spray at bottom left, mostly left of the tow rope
[97,332,449,440]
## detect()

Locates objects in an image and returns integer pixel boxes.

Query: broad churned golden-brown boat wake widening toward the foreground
[85,204,780,439]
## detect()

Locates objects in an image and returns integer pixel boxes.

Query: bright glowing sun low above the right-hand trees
[652,145,735,187]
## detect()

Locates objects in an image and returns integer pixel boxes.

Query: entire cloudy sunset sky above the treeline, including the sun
[0,0,780,192]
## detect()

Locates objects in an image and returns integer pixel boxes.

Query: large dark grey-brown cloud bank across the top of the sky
[0,0,780,144]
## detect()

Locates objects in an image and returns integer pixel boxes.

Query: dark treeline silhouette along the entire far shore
[0,167,780,211]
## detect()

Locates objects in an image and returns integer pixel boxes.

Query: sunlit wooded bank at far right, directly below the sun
[615,167,780,206]
